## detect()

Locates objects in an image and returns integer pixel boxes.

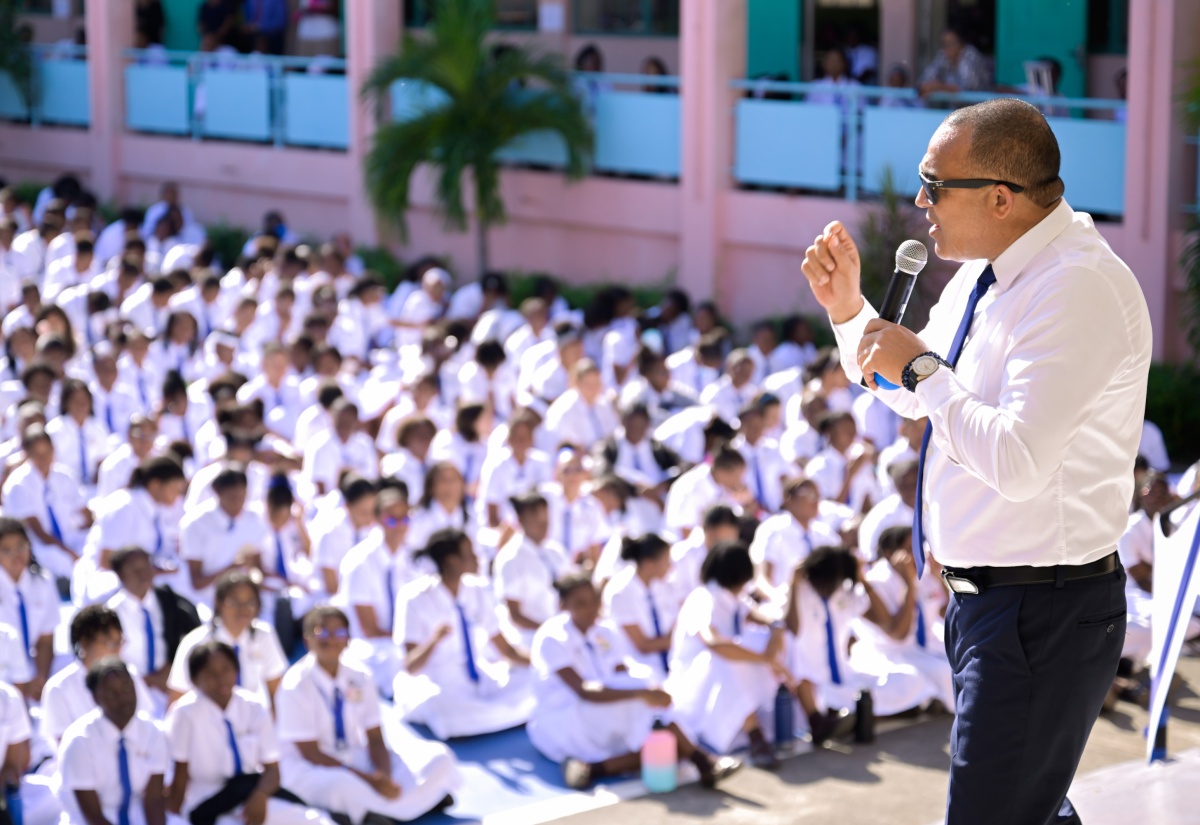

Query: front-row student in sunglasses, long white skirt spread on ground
[276,607,460,825]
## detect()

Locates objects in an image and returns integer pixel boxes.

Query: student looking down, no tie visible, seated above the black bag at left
[179,464,266,608]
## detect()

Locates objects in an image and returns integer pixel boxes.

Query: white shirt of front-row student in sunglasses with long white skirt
[275,654,383,764]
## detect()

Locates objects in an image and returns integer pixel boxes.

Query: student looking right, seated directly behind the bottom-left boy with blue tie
[40,604,156,746]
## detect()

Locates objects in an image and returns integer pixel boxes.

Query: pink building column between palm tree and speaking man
[678,0,746,311]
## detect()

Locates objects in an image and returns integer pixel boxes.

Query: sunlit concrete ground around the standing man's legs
[559,658,1200,825]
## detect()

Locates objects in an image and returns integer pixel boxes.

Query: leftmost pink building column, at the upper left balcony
[80,2,133,201]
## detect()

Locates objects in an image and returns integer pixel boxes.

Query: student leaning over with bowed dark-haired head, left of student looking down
[71,456,187,606]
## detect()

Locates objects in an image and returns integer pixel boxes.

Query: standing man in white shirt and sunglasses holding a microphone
[803,98,1153,825]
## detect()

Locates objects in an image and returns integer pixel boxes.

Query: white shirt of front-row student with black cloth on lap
[166,687,280,813]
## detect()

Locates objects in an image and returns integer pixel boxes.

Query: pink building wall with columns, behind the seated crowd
[0,0,1200,357]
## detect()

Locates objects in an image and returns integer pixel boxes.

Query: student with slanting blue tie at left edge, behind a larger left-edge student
[4,424,91,578]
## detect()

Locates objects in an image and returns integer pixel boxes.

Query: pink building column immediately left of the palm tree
[344,0,403,246]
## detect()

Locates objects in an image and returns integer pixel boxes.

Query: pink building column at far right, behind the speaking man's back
[1118,0,1200,360]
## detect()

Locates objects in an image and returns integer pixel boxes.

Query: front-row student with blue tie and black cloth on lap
[167,639,332,825]
